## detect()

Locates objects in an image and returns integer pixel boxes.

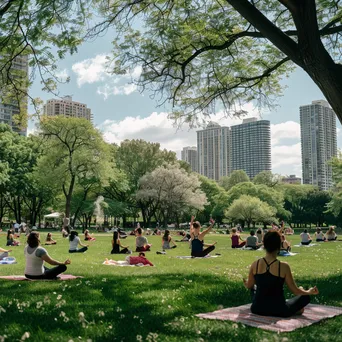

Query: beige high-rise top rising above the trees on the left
[44,96,93,122]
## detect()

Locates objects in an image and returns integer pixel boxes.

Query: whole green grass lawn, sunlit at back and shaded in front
[0,233,342,342]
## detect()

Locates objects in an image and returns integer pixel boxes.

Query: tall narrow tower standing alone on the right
[299,100,337,190]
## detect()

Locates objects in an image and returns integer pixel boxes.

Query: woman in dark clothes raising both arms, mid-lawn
[190,216,216,258]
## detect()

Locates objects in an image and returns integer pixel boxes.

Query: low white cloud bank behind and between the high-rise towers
[99,106,301,175]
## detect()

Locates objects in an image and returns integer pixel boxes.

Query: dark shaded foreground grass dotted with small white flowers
[0,274,342,342]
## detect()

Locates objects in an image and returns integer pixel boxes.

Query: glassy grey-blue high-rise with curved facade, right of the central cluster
[231,118,271,178]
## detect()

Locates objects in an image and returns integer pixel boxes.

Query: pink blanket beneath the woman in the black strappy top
[196,304,342,332]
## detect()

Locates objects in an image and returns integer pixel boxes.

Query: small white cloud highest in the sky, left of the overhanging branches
[72,54,142,100]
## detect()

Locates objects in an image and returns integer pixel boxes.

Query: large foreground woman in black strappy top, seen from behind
[243,231,319,317]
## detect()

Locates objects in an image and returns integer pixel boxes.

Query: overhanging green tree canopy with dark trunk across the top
[0,0,342,122]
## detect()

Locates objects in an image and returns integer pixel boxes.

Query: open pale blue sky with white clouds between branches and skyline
[29,32,342,177]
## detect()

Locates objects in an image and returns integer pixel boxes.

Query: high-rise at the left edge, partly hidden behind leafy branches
[0,56,28,135]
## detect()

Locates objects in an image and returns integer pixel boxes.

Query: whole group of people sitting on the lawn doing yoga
[4,216,337,317]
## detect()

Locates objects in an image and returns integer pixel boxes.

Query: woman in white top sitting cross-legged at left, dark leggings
[24,232,71,279]
